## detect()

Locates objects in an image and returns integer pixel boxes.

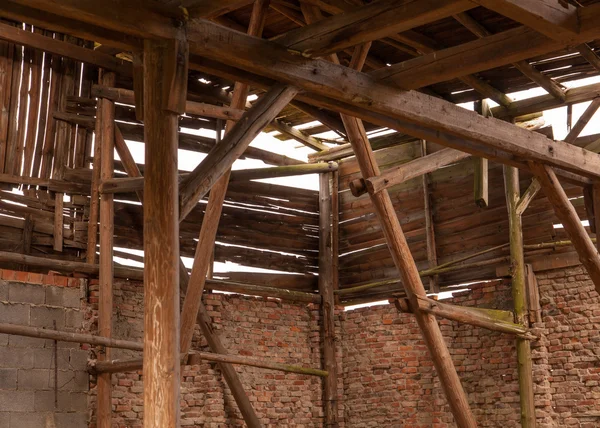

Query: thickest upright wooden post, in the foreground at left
[143,40,186,428]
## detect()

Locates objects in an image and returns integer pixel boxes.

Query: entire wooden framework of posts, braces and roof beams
[0,0,600,428]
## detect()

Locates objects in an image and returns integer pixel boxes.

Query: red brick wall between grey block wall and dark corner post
[90,281,332,428]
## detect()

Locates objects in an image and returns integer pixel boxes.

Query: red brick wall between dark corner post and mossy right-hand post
[342,282,520,428]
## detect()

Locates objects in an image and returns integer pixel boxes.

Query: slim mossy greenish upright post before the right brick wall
[504,166,536,428]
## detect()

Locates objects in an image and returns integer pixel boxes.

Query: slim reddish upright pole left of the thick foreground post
[93,71,116,428]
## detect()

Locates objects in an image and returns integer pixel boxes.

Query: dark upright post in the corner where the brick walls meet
[319,173,339,427]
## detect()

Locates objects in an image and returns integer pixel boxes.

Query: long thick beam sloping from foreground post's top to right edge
[189,19,600,181]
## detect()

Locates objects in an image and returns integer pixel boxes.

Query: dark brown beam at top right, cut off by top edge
[473,0,579,42]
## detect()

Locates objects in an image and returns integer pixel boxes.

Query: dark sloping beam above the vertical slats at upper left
[0,23,131,76]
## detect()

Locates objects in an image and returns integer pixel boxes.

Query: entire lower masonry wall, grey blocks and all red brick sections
[0,267,600,428]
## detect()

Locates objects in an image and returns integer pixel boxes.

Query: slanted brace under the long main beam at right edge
[530,162,600,291]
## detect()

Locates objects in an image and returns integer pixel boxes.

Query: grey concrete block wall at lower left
[0,270,90,428]
